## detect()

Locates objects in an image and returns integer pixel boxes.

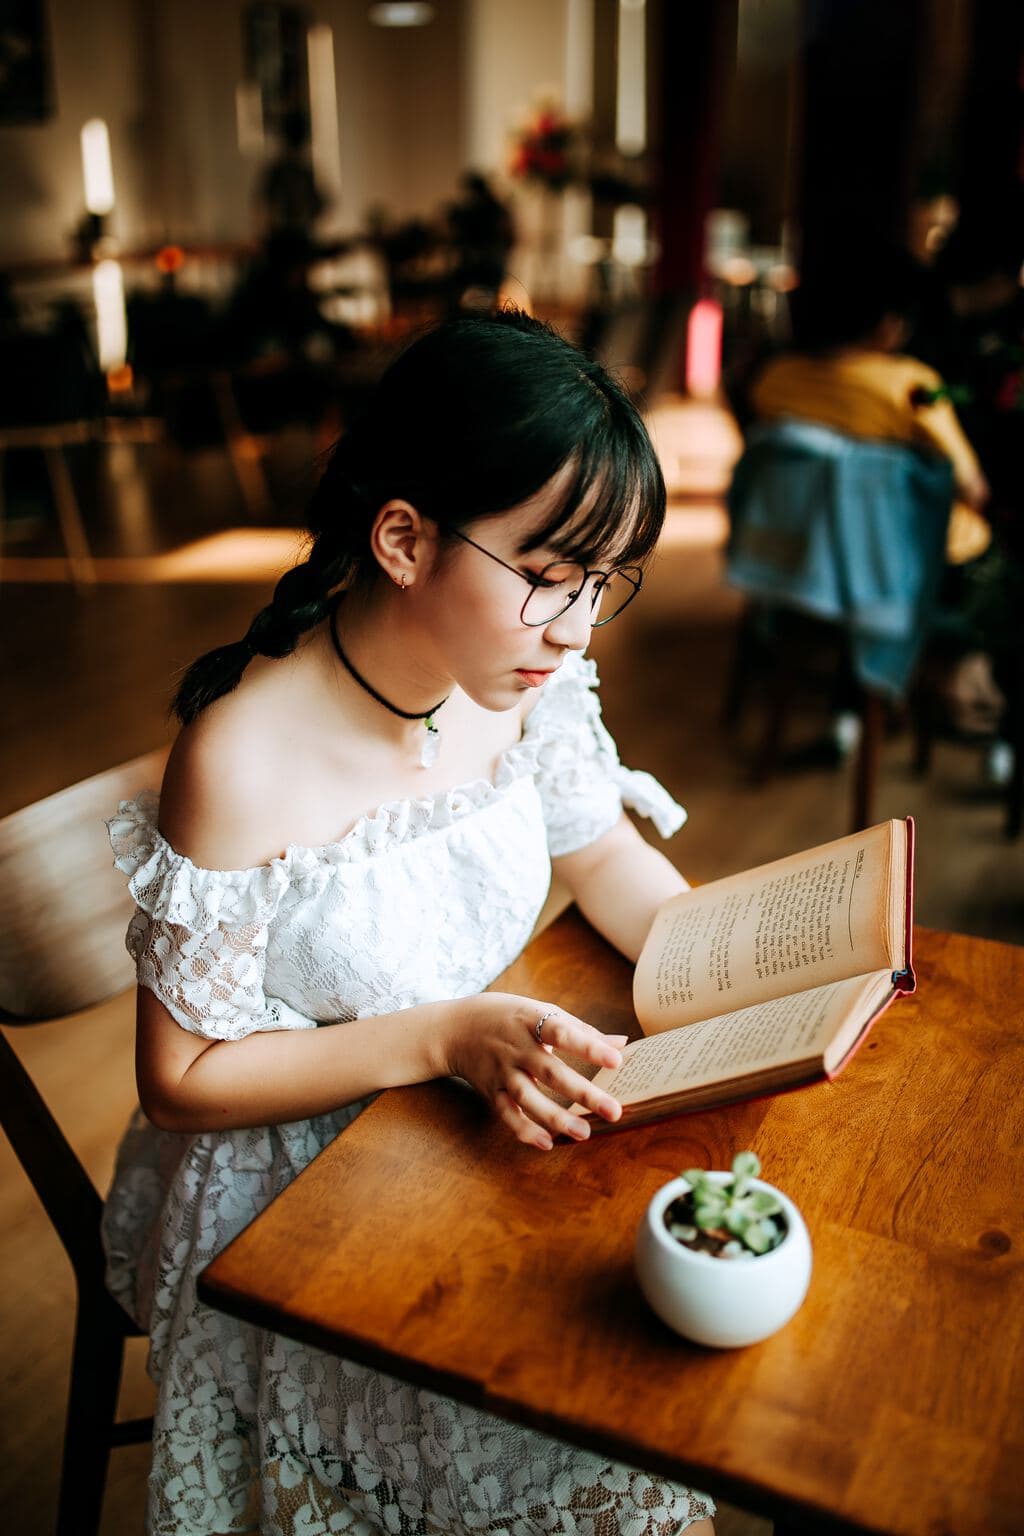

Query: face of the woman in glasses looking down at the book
[418,467,617,710]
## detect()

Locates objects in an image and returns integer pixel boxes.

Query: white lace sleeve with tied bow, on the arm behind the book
[524,653,686,859]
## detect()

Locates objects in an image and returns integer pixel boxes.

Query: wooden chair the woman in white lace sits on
[0,750,166,1536]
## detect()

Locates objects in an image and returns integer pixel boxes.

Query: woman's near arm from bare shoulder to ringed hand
[137,700,620,1147]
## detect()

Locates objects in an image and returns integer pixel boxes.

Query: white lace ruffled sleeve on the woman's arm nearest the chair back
[107,794,316,1040]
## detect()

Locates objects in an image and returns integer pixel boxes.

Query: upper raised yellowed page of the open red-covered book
[633,822,907,1035]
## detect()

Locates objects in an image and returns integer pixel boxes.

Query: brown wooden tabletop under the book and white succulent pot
[200,911,1024,1536]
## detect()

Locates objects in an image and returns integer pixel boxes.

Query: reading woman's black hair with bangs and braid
[173,309,665,723]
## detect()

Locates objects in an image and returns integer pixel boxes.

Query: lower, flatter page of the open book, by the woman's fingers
[594,971,892,1106]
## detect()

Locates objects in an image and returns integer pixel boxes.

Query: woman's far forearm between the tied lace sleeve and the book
[551,813,689,962]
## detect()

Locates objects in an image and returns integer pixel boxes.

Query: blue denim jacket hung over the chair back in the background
[726,418,953,697]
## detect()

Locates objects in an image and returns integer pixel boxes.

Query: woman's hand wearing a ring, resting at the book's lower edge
[445,992,628,1152]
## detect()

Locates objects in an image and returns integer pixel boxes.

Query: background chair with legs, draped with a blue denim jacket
[725,419,952,829]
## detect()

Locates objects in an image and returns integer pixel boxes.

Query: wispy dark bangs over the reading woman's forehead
[522,419,665,565]
